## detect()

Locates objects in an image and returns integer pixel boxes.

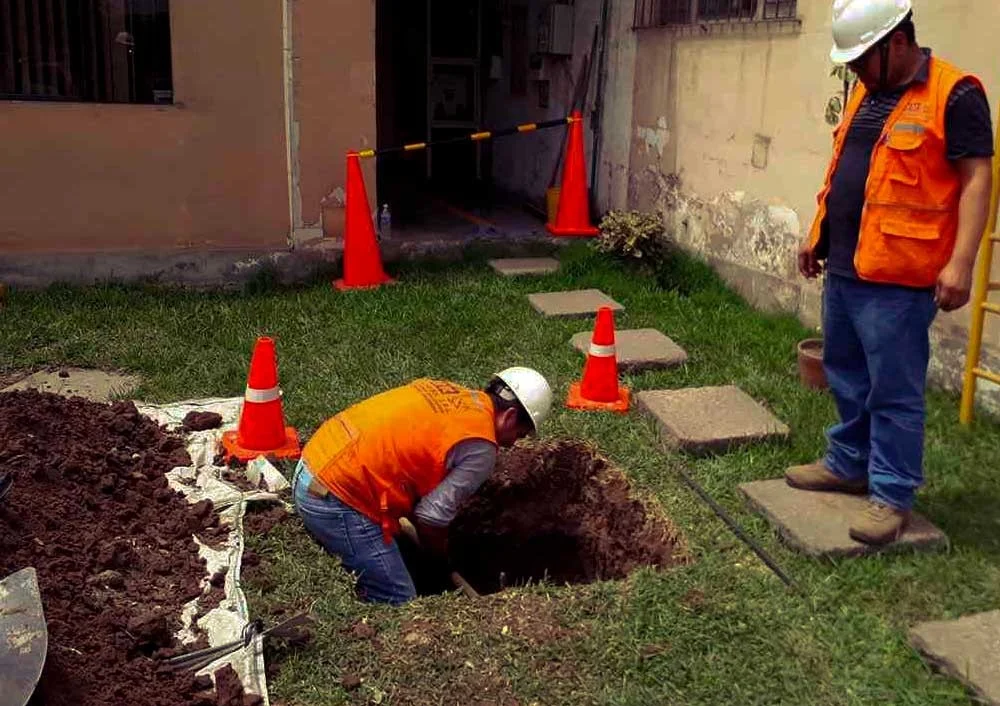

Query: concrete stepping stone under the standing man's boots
[739,478,948,557]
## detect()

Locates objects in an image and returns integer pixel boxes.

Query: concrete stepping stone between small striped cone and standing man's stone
[636,385,788,454]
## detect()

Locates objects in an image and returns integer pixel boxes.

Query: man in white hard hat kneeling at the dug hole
[293,367,552,605]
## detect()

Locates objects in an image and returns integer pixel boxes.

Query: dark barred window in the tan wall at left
[0,0,173,103]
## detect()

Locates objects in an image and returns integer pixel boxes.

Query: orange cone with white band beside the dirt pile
[222,336,301,463]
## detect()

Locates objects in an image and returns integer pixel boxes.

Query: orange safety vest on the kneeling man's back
[302,379,497,543]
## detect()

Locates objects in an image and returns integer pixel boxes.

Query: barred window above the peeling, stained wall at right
[633,0,796,29]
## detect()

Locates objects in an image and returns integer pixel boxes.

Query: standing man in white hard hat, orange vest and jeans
[786,0,993,544]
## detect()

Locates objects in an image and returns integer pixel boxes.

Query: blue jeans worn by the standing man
[823,275,937,510]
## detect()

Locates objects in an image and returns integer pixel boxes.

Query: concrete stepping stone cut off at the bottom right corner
[910,610,1000,706]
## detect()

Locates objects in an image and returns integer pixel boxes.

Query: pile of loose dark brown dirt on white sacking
[0,391,254,706]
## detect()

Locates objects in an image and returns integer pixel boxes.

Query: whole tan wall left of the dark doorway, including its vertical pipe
[0,0,375,253]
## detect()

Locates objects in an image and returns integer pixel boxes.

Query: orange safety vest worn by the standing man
[809,57,983,287]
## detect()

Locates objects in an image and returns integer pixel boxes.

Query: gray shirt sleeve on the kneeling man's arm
[413,439,497,527]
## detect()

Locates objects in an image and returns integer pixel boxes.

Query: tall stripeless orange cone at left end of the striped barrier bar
[333,152,392,291]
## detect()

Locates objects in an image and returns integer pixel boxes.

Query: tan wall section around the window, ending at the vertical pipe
[0,0,289,252]
